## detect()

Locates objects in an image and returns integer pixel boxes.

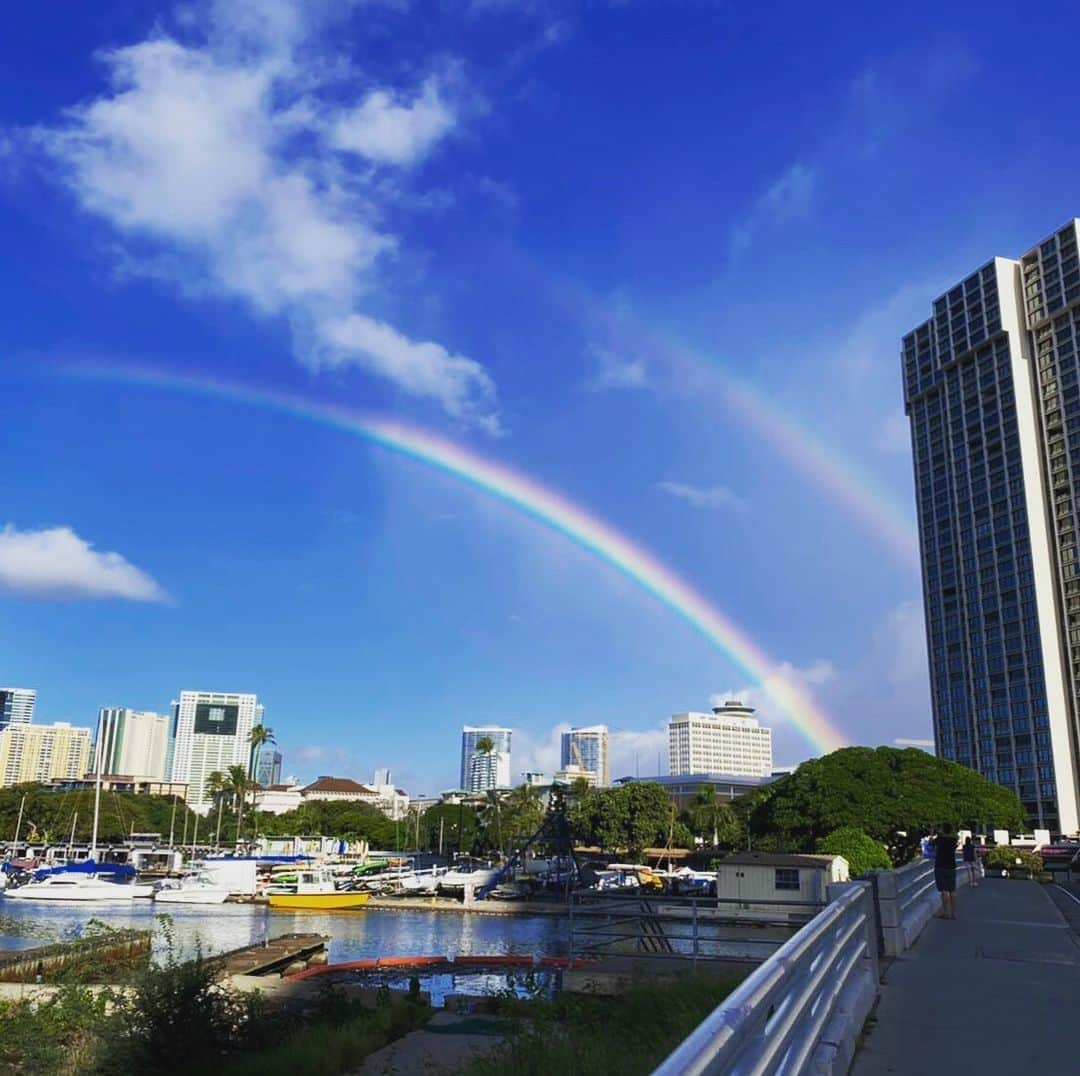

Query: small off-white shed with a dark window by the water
[716,852,848,920]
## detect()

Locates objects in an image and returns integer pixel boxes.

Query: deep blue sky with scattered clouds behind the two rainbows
[0,0,1080,792]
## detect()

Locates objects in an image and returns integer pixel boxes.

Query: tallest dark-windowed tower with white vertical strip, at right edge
[902,220,1080,833]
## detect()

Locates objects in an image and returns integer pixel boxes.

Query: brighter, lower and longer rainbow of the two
[65,362,847,752]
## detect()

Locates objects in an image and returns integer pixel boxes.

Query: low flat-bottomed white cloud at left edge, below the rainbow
[0,524,166,602]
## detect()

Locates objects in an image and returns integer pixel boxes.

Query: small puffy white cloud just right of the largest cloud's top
[330,79,455,164]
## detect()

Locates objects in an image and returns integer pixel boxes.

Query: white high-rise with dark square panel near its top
[170,691,262,811]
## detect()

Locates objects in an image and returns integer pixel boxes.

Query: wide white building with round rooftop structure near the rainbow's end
[667,699,772,777]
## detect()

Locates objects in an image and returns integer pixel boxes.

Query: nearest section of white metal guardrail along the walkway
[653,881,876,1076]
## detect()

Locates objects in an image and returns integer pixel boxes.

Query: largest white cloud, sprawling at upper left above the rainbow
[23,7,498,429]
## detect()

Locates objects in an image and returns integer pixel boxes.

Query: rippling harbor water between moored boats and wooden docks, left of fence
[0,898,569,964]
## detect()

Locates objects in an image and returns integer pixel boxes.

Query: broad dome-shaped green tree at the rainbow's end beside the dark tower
[737,748,1024,865]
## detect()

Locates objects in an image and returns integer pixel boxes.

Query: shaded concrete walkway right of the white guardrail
[851,878,1080,1076]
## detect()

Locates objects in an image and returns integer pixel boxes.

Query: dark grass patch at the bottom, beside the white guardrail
[461,971,743,1076]
